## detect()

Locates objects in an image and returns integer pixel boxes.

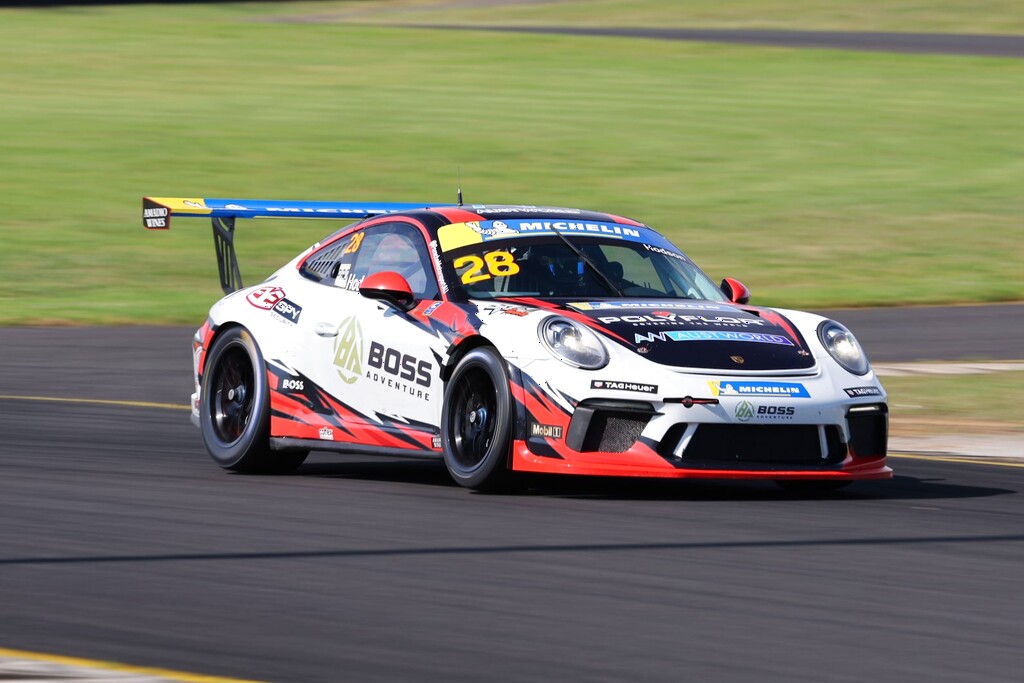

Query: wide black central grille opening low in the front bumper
[682,424,846,469]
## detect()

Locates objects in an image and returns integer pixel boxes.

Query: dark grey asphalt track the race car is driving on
[0,305,1024,682]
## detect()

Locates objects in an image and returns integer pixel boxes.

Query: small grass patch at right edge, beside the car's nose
[883,372,1024,433]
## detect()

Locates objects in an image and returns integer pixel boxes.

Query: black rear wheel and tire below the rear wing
[200,327,309,474]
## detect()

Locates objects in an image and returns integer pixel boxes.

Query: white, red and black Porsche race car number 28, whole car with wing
[142,198,892,490]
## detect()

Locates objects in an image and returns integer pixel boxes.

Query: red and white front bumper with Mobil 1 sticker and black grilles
[512,368,892,480]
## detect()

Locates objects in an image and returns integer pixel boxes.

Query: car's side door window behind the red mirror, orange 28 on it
[335,223,440,299]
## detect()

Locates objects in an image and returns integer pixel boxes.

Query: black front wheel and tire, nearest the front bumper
[441,346,514,492]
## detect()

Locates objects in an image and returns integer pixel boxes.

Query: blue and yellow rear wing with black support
[142,197,436,294]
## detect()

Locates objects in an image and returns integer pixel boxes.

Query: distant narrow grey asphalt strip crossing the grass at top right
[395,24,1024,57]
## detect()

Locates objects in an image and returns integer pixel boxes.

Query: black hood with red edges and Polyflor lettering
[566,300,814,372]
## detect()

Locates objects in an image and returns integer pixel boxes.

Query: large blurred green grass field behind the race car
[0,3,1024,325]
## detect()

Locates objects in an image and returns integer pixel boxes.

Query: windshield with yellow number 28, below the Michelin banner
[444,233,726,301]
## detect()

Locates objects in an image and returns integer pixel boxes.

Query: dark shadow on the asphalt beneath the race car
[293,454,1018,502]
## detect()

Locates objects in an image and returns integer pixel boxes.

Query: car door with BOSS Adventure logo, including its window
[296,222,446,450]
